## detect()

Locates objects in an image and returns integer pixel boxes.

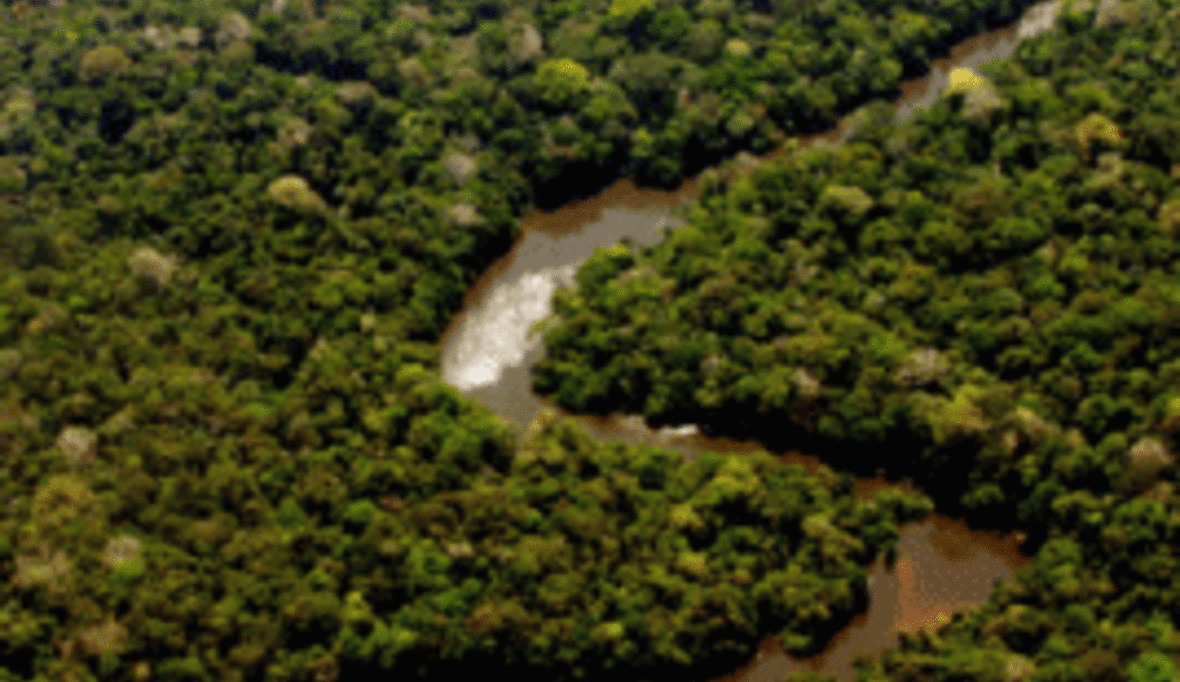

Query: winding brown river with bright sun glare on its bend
[443,0,1058,682]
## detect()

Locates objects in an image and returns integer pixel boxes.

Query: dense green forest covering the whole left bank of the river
[0,0,1071,681]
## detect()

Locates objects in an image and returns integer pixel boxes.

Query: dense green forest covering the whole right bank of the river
[536,0,1180,682]
